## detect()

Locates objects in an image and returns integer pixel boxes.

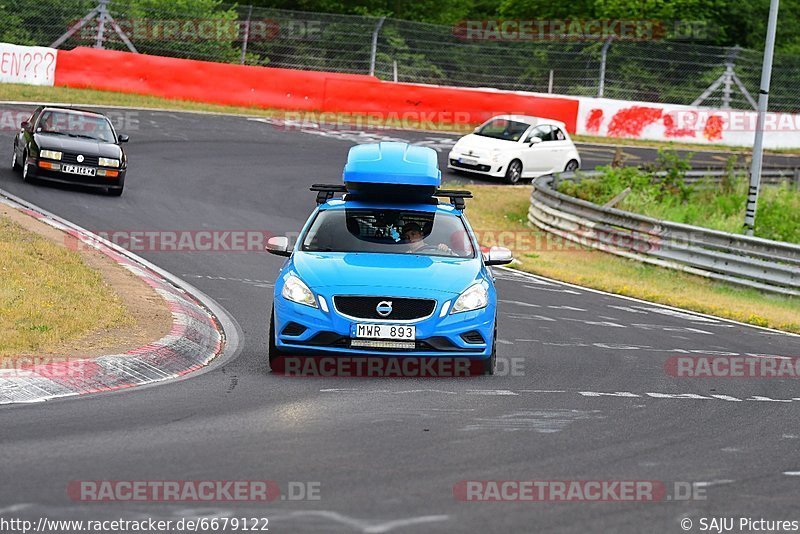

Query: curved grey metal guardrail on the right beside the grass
[528,171,800,296]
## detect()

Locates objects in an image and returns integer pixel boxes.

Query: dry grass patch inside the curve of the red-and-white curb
[0,211,129,357]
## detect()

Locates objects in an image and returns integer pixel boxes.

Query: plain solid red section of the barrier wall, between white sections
[55,48,578,133]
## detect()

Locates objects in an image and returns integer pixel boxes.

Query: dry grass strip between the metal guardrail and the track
[468,185,800,333]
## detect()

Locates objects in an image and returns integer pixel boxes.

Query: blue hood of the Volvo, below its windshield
[292,252,481,296]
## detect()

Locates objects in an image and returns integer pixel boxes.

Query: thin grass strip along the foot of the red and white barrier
[0,84,800,154]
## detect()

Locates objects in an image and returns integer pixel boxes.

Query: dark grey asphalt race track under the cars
[0,107,800,532]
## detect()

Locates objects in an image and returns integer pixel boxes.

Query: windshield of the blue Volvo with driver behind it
[302,208,474,258]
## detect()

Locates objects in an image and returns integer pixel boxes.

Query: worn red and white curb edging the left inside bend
[0,190,231,404]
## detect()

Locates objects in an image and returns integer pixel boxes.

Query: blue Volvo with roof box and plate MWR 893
[267,142,511,374]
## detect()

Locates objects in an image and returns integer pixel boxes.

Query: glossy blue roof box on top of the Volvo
[342,141,442,196]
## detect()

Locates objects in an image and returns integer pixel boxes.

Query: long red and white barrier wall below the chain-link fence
[0,44,800,148]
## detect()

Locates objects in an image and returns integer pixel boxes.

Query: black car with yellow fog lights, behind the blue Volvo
[12,106,128,196]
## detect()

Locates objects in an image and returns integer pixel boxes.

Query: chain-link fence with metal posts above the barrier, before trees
[6,0,800,112]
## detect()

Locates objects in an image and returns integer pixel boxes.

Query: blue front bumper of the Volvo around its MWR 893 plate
[274,294,495,359]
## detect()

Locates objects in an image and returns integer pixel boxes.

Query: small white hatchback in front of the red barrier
[447,115,581,184]
